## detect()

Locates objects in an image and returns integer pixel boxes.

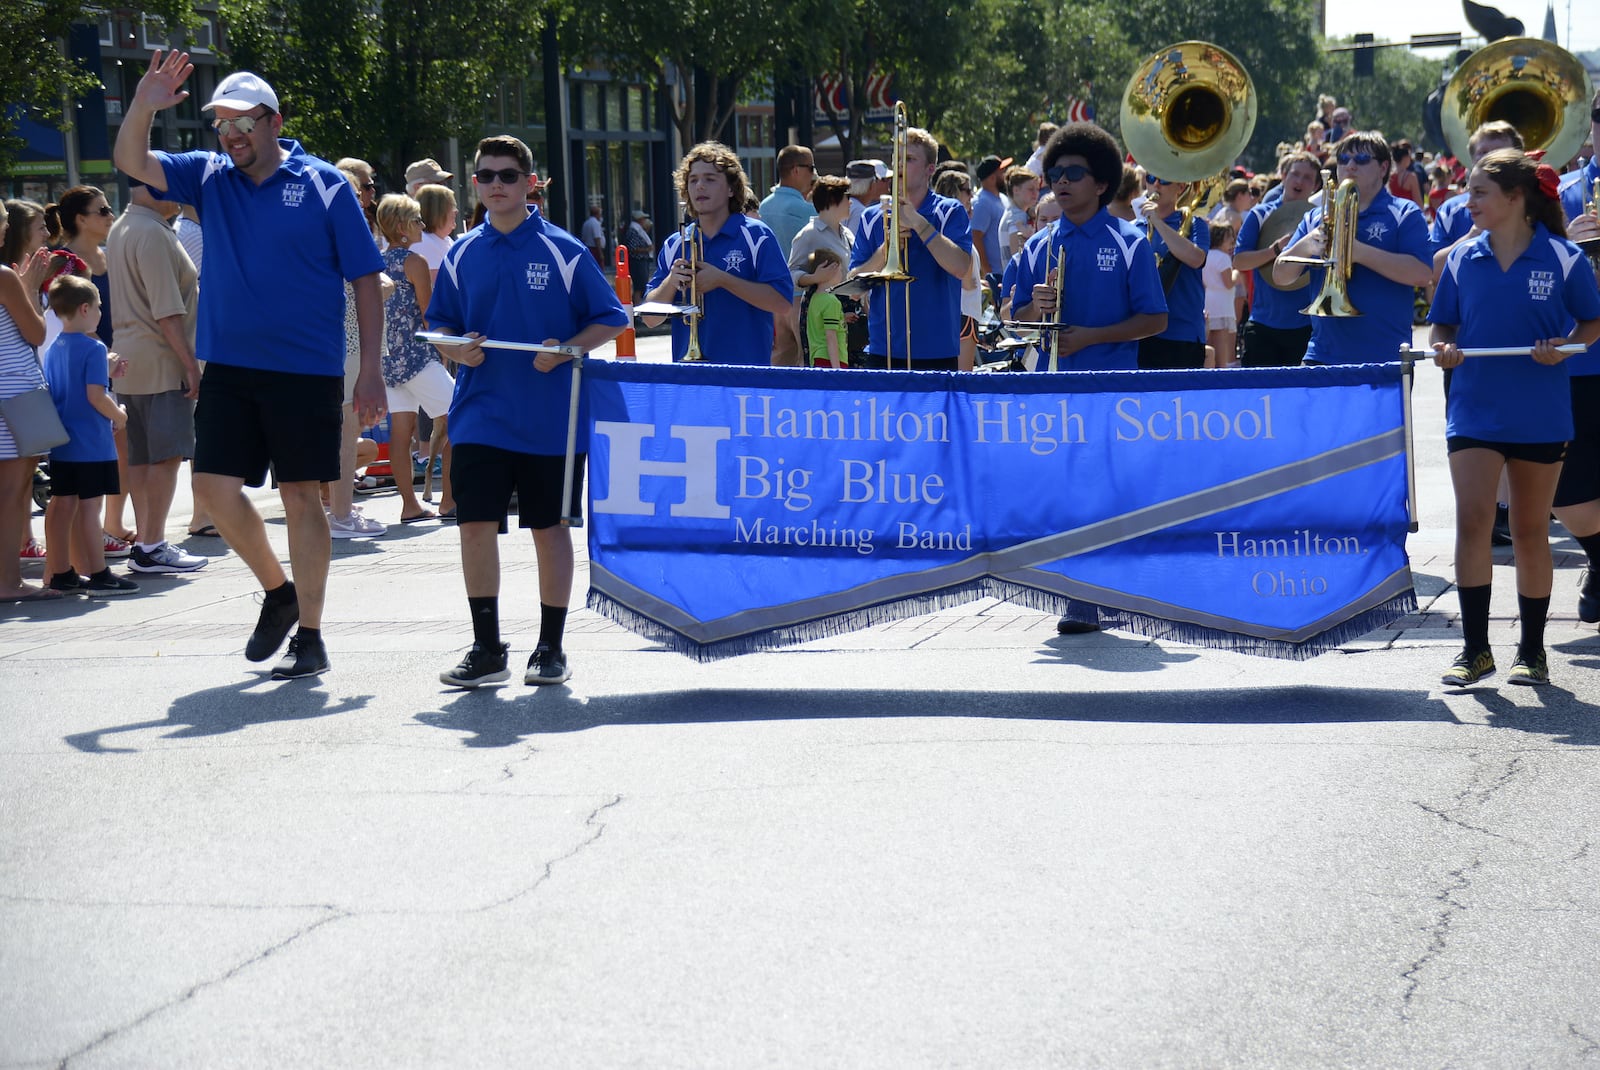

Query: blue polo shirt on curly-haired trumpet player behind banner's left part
[645,214,795,368]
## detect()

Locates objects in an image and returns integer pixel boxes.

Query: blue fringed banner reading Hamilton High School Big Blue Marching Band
[584,360,1416,659]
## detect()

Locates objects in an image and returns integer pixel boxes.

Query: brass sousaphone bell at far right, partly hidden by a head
[1438,37,1594,171]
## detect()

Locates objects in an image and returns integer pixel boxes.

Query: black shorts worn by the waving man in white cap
[194,361,344,486]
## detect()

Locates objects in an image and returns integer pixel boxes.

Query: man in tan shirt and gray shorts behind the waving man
[106,179,208,573]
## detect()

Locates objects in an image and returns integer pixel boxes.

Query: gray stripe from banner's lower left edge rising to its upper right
[589,429,1405,643]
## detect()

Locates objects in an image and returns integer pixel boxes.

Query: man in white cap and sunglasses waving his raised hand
[115,51,386,680]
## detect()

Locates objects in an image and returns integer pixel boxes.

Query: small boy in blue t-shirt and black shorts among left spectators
[45,275,139,598]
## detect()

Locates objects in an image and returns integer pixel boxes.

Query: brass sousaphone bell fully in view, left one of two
[1122,42,1256,210]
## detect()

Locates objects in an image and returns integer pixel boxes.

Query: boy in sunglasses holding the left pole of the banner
[427,136,627,688]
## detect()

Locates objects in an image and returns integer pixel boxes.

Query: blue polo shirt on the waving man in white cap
[150,139,384,377]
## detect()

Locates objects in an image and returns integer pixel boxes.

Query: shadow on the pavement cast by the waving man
[64,673,373,755]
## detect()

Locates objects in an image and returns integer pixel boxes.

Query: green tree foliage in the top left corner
[0,0,195,171]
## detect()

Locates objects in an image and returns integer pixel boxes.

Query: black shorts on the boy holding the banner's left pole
[450,441,587,531]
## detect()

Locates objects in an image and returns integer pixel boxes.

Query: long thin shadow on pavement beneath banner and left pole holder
[416,686,1458,747]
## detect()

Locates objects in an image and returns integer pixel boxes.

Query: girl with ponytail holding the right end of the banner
[1429,149,1600,686]
